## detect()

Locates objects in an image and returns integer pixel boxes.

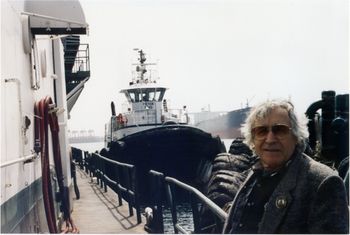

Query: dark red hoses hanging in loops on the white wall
[34,97,79,233]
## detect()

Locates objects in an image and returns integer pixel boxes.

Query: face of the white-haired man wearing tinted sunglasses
[252,107,297,170]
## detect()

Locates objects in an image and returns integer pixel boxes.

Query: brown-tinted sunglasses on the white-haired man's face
[252,124,292,140]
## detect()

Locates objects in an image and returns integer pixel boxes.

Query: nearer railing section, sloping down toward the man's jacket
[150,170,227,234]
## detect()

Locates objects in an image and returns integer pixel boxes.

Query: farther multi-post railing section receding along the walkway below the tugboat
[72,149,142,223]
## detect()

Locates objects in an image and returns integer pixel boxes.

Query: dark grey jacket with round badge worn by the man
[223,154,349,234]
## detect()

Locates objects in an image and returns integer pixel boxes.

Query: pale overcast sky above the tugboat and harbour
[69,0,349,135]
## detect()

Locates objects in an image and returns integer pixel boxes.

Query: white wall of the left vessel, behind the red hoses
[0,1,87,232]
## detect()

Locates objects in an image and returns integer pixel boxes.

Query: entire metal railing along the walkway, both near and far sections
[71,148,227,234]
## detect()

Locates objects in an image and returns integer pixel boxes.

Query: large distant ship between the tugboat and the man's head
[192,106,251,139]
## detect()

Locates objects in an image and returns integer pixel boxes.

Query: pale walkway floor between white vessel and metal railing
[71,167,147,234]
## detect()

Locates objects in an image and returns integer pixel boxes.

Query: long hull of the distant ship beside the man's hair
[196,107,250,139]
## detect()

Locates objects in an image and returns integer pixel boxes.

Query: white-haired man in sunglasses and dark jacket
[223,100,349,233]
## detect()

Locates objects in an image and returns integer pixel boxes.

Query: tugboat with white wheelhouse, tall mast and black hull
[101,49,226,202]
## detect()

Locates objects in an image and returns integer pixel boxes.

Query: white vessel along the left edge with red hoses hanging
[1,0,90,233]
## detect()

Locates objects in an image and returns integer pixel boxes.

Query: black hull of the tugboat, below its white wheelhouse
[104,125,226,203]
